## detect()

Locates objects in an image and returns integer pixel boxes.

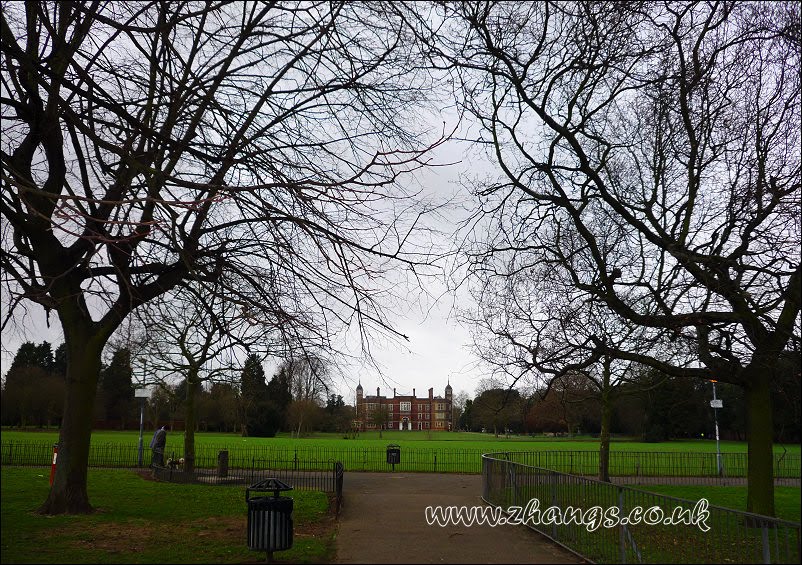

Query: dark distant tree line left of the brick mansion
[1,341,353,437]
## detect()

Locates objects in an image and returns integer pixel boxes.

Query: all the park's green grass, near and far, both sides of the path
[2,430,800,563]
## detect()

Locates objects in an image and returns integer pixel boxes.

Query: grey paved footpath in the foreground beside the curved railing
[336,473,584,564]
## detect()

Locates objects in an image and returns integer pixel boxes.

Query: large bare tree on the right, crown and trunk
[433,2,802,515]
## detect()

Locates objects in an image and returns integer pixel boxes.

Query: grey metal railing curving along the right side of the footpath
[482,453,800,563]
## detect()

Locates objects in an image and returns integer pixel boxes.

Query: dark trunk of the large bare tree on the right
[745,368,774,516]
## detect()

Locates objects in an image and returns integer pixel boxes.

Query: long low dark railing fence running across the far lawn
[0,441,802,484]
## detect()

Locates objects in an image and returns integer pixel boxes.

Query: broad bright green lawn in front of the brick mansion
[0,429,800,477]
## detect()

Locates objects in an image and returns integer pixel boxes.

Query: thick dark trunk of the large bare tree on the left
[39,324,105,514]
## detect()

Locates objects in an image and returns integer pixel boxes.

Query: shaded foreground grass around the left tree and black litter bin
[0,467,335,563]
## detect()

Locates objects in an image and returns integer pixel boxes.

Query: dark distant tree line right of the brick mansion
[457,361,802,443]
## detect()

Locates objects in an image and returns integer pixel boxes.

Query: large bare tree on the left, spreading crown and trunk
[0,1,440,513]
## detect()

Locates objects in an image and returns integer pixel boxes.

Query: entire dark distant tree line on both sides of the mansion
[7,341,802,443]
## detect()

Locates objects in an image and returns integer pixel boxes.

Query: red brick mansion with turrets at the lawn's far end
[355,383,453,430]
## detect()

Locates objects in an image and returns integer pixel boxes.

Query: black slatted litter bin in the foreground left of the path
[245,479,294,556]
